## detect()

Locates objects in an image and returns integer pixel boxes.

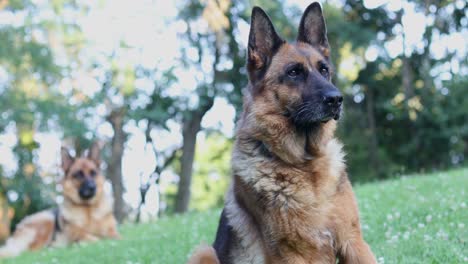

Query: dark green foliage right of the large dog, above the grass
[334,1,467,180]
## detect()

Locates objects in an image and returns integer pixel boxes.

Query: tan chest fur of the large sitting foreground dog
[228,133,346,263]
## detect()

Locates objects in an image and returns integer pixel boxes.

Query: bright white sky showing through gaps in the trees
[0,0,468,221]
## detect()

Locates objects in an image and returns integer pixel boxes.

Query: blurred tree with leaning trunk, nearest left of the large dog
[175,0,231,213]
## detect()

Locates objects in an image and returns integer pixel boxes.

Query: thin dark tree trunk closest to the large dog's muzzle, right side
[366,87,382,178]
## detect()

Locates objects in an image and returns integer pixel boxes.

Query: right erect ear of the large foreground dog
[297,2,330,54]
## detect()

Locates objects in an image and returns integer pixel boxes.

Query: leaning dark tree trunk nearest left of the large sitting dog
[175,111,206,213]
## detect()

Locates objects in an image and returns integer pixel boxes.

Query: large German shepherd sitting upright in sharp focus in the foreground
[189,3,376,264]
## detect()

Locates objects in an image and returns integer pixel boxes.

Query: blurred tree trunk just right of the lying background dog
[107,109,126,223]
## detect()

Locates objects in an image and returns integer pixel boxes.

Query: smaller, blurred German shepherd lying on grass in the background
[0,143,119,257]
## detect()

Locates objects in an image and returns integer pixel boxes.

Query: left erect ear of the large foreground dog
[247,6,284,82]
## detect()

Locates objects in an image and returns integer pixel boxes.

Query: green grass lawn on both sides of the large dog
[5,169,468,264]
